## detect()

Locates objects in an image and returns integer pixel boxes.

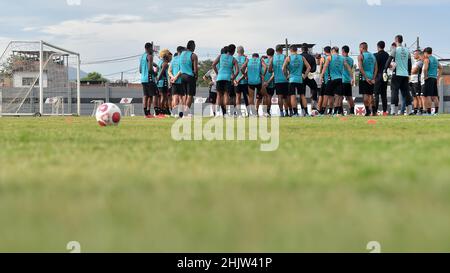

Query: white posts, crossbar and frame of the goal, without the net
[0,40,81,116]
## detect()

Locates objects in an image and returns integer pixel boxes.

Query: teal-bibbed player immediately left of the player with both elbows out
[269,45,292,117]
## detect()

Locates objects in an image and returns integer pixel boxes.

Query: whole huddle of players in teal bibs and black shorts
[140,35,442,118]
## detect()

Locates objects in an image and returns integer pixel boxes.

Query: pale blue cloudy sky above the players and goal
[0,0,450,80]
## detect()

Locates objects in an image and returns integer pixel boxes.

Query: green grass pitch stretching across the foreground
[0,115,450,252]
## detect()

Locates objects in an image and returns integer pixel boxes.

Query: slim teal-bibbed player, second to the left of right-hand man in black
[341,46,355,115]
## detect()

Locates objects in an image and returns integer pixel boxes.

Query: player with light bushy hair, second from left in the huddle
[155,49,172,117]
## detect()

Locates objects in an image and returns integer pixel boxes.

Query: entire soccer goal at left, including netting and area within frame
[0,41,81,116]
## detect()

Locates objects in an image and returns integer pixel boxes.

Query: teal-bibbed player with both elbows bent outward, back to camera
[283,45,311,117]
